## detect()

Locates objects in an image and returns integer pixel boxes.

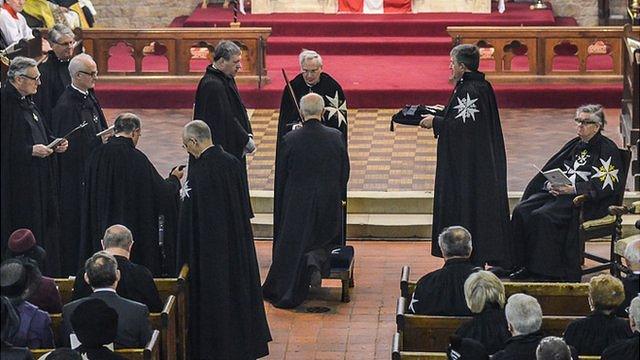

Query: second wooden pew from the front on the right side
[396,297,579,352]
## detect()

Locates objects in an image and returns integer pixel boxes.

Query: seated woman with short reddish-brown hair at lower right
[564,275,632,355]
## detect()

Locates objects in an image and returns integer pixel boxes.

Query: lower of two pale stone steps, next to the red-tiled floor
[251,213,640,240]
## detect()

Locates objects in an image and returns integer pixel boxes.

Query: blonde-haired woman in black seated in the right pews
[456,270,511,354]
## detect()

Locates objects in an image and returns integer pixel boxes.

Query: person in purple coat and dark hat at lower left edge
[0,259,54,349]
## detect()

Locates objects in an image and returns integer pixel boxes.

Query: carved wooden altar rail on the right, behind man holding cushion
[447,26,640,83]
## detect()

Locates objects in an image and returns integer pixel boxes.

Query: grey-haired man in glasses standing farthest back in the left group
[33,24,76,124]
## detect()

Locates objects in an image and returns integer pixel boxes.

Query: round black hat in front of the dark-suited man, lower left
[71,298,118,348]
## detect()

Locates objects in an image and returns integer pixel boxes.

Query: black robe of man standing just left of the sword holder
[193,65,253,217]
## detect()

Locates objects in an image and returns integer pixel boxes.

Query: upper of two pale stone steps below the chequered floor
[251,190,640,215]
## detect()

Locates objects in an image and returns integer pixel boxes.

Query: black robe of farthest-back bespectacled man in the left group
[33,50,71,124]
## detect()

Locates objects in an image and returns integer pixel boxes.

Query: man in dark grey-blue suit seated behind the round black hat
[62,251,151,348]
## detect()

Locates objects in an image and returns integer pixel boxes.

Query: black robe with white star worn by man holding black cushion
[431,72,509,267]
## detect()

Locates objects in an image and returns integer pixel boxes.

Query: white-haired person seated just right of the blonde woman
[491,294,544,360]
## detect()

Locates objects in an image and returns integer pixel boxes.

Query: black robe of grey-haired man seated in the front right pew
[409,258,477,316]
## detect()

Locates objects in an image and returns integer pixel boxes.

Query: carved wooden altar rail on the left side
[75,28,271,85]
